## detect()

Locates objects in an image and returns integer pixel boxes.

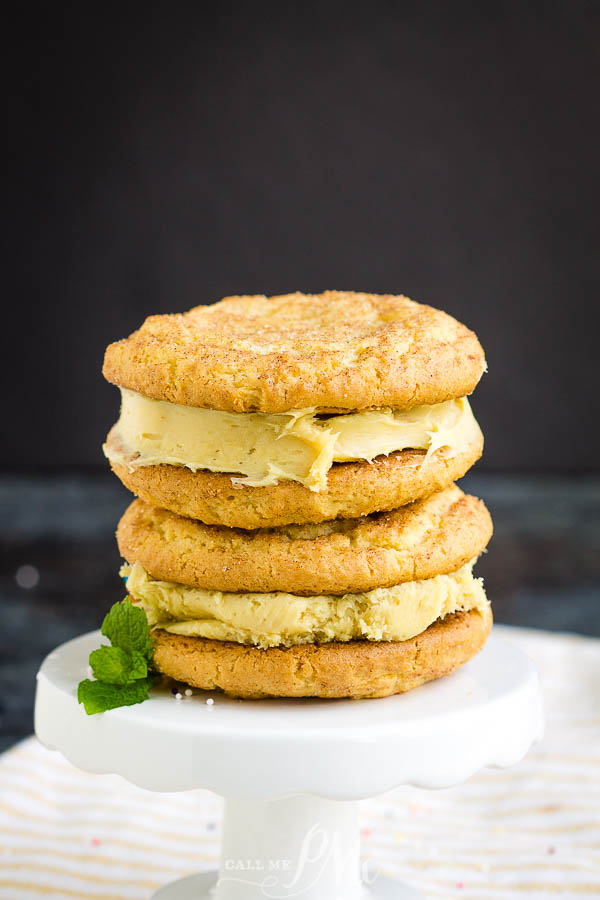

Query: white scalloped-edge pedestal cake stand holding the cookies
[35,632,542,900]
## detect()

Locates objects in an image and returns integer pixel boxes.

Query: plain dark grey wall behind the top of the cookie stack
[8,2,600,470]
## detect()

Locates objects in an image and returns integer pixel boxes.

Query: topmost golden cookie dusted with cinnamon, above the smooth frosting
[103,291,485,413]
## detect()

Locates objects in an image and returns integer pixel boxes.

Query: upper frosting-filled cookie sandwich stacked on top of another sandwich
[103,291,485,528]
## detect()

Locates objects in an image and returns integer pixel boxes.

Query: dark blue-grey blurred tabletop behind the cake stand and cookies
[0,473,600,749]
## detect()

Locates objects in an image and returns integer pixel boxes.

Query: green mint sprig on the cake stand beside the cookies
[77,597,153,715]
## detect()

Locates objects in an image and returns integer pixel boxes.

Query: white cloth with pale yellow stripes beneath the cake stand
[0,626,600,900]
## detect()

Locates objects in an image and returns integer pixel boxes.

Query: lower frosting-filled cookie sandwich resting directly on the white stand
[117,485,492,698]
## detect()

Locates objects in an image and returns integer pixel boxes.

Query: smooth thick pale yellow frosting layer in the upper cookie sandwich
[104,389,476,491]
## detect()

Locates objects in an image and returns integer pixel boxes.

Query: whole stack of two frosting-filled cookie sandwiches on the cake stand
[104,291,492,698]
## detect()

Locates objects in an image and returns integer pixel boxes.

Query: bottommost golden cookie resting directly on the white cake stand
[153,607,492,699]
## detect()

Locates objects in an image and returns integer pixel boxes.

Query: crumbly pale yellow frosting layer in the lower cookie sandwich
[121,560,488,648]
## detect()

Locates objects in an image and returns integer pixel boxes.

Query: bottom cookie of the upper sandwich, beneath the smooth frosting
[108,420,483,529]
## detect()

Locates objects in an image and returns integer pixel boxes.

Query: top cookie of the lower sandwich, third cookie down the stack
[117,485,492,596]
